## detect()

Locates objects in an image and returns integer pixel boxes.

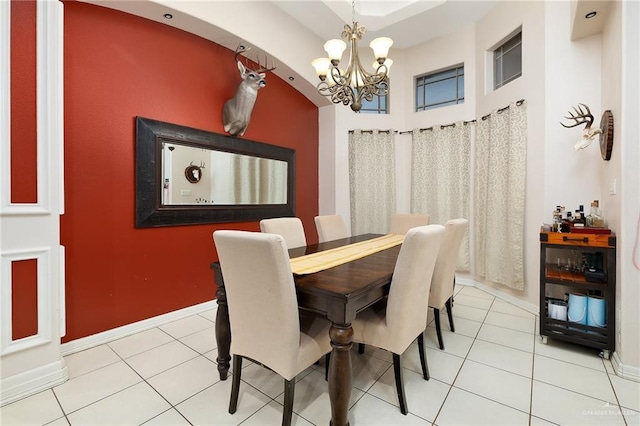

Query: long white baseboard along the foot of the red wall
[60,300,218,356]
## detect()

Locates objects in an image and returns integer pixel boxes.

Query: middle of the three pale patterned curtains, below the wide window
[411,122,474,271]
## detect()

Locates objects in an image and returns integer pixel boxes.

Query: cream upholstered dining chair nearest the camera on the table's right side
[351,225,444,415]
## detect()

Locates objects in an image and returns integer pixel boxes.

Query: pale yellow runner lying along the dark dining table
[291,234,404,275]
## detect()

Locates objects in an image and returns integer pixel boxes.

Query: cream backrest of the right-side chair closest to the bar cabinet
[429,218,469,309]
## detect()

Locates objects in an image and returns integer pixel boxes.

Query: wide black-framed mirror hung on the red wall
[135,117,295,228]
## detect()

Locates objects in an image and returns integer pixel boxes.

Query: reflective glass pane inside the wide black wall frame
[161,141,287,206]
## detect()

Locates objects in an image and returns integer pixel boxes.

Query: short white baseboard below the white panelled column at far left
[0,359,68,407]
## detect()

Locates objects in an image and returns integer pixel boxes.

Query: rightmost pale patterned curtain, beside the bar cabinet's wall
[473,101,527,290]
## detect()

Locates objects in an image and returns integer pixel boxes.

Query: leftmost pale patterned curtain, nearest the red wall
[349,130,396,235]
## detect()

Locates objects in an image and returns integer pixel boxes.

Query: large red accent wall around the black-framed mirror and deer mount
[61,1,318,341]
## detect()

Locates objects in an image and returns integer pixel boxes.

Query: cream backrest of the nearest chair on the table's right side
[386,225,445,354]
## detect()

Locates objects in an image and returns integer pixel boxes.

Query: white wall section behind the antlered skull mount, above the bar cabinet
[544,2,608,215]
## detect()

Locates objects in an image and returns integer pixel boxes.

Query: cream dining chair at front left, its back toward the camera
[213,230,331,425]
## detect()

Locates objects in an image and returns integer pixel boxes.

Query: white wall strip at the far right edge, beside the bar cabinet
[599,1,640,380]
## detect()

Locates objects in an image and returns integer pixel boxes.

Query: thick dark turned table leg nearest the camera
[329,323,353,426]
